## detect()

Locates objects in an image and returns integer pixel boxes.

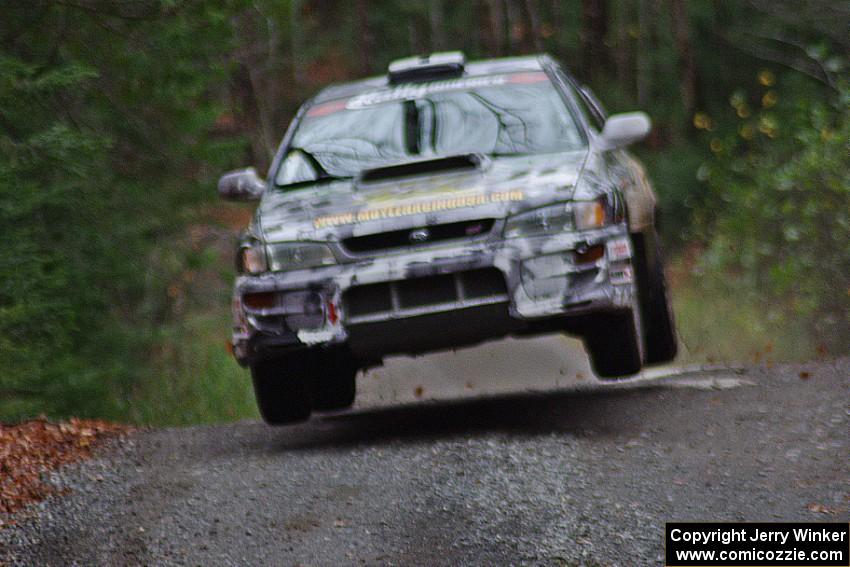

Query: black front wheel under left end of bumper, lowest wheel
[251,356,313,425]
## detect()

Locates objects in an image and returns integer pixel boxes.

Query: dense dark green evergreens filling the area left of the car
[0,3,245,419]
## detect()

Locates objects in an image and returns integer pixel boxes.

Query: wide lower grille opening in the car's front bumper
[343,268,508,325]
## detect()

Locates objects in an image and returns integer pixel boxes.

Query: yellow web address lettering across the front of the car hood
[313,189,525,228]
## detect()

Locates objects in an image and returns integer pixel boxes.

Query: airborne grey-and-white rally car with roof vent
[218,53,676,424]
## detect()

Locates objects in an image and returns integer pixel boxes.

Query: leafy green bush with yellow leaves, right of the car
[701,75,850,352]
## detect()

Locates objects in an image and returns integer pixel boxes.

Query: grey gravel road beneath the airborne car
[0,341,850,566]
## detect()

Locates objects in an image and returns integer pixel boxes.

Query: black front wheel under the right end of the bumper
[582,311,642,379]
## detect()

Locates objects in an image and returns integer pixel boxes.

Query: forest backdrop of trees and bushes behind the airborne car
[0,0,850,423]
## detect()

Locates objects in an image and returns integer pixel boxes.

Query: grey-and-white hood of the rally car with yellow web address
[256,150,587,242]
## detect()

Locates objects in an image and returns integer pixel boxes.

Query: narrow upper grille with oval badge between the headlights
[342,219,495,254]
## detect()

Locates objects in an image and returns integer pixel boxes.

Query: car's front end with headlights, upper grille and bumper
[233,174,635,364]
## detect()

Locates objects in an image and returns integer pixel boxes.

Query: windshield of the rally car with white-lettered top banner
[275,72,585,185]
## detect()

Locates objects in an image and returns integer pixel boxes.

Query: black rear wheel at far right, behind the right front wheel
[634,231,679,364]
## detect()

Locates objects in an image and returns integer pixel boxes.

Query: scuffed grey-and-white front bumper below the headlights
[233,224,636,364]
